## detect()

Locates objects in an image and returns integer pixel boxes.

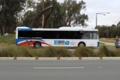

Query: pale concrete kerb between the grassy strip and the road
[0,57,120,60]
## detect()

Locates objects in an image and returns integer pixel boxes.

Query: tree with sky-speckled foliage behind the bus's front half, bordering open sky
[62,0,88,26]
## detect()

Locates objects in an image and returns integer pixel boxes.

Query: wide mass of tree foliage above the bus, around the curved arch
[23,0,88,28]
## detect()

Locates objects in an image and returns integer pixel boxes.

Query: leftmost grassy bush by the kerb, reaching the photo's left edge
[0,46,36,57]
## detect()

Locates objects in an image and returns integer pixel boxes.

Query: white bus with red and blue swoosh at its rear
[16,27,99,48]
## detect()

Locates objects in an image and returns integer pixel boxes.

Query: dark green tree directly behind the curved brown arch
[23,0,63,28]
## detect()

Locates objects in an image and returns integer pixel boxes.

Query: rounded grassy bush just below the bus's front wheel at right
[73,47,96,57]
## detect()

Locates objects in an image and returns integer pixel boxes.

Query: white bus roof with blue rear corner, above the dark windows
[17,27,98,31]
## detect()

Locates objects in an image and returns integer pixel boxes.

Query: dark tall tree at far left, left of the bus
[0,0,26,35]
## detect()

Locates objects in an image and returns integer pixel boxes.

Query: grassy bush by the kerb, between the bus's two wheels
[37,46,71,57]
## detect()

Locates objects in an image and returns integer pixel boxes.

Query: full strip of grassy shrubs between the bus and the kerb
[0,45,120,57]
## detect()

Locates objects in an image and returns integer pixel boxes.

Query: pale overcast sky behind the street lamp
[57,0,120,28]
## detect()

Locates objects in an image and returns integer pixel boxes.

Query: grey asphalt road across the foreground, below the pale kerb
[0,60,120,80]
